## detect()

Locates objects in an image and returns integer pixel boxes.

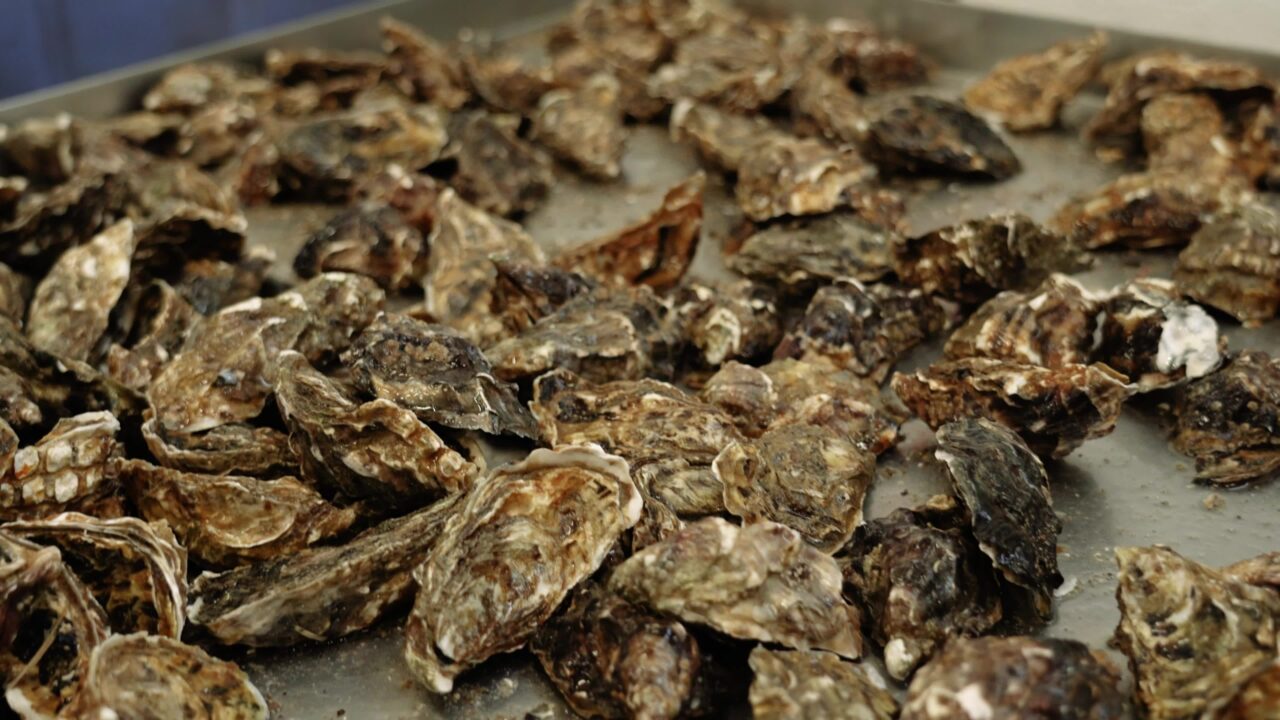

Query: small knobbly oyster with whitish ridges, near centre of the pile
[675,279,782,368]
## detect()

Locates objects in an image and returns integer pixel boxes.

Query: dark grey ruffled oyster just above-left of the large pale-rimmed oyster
[343,313,535,438]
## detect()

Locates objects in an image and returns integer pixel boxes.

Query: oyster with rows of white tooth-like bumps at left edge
[0,411,123,518]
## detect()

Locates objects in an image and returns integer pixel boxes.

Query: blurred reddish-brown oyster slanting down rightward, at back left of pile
[381,18,471,110]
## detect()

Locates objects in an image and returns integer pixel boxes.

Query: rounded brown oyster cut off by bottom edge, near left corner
[68,633,270,720]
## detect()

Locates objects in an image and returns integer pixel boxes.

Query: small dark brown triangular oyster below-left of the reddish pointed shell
[489,260,598,336]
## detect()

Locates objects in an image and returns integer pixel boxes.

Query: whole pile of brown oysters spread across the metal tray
[0,0,1280,720]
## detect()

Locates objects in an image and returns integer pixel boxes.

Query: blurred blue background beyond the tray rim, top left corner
[0,0,353,97]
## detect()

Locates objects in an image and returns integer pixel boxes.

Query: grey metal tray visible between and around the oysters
[0,0,1280,719]
